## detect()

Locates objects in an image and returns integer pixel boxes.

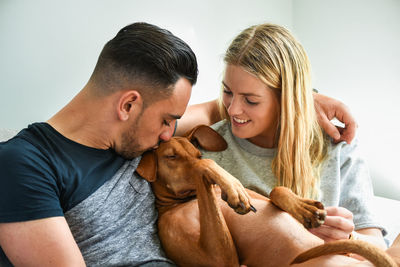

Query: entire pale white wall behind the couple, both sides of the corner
[0,0,400,199]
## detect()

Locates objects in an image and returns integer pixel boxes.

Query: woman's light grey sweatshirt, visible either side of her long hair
[202,120,385,233]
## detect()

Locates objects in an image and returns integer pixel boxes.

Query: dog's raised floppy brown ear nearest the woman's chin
[185,125,228,151]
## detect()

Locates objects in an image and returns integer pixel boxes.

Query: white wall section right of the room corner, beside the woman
[293,0,400,200]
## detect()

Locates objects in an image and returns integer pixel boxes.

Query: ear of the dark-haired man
[117,90,143,121]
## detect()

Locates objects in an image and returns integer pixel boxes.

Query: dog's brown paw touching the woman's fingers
[295,199,326,228]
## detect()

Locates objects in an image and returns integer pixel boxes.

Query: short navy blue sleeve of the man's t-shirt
[0,138,63,222]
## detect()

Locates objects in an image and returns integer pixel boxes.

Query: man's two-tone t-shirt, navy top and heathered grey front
[0,123,175,266]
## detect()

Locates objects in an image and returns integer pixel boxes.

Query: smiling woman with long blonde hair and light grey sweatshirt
[179,24,386,251]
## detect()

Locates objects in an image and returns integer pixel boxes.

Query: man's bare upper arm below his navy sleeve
[0,217,85,266]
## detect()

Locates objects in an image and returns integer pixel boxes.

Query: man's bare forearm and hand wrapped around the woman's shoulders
[176,93,357,144]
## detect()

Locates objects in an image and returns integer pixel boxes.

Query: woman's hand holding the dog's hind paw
[309,207,354,242]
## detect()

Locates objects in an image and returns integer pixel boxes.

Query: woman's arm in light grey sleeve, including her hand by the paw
[310,136,386,249]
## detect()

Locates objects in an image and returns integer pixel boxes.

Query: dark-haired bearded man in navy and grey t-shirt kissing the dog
[0,23,354,266]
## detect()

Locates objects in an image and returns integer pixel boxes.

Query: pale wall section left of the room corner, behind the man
[0,0,292,129]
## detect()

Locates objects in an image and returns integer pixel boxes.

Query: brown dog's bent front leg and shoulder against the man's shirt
[158,160,241,267]
